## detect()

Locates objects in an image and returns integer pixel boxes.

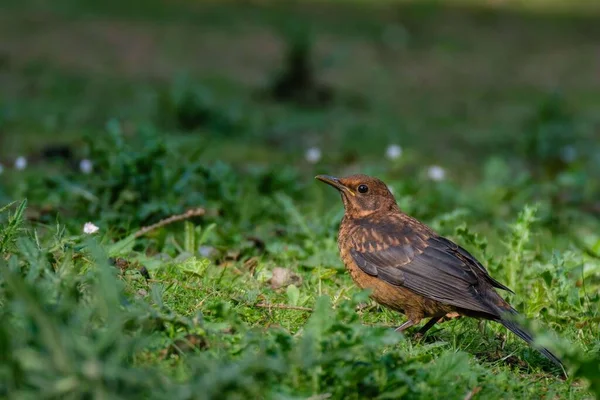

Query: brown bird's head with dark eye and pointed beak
[315,175,398,218]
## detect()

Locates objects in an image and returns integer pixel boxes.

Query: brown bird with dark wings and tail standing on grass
[316,175,564,371]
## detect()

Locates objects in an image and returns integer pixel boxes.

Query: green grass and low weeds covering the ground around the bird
[0,0,600,399]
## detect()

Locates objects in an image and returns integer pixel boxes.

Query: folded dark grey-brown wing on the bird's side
[350,222,503,314]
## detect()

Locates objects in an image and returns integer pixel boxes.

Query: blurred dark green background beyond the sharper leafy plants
[0,0,600,176]
